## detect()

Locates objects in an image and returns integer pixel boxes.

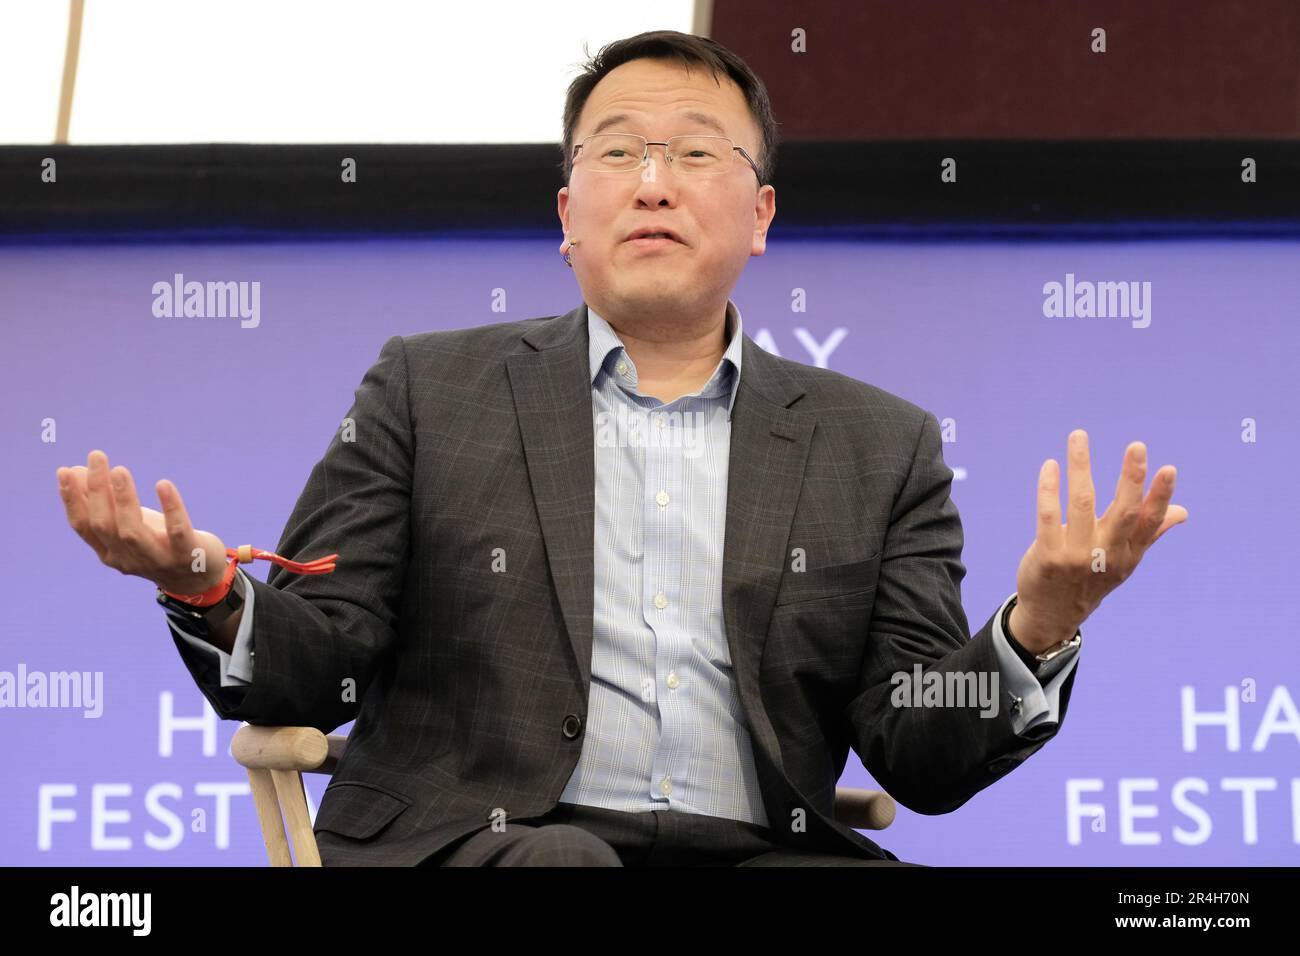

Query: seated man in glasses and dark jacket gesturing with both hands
[59,31,1187,865]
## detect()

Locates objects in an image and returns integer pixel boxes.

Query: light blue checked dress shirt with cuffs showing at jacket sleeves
[168,300,1078,826]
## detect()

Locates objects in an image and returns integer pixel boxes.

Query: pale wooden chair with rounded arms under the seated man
[230,724,897,866]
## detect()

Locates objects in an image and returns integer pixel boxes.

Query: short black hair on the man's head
[560,30,779,185]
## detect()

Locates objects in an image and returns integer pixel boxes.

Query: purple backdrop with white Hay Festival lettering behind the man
[0,234,1300,865]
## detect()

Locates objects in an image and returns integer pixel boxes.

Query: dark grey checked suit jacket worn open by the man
[173,304,1078,865]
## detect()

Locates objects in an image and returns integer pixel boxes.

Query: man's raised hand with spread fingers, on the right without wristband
[1008,428,1187,653]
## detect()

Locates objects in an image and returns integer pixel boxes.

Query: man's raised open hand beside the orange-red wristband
[56,450,229,594]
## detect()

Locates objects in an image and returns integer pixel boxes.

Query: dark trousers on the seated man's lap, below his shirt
[420,803,920,866]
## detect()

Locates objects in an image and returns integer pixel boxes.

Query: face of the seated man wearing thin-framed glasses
[558,60,776,316]
